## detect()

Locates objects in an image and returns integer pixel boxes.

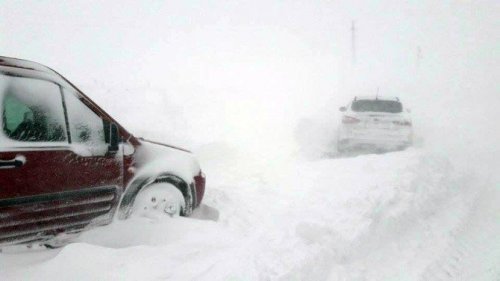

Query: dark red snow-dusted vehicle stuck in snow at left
[0,57,205,249]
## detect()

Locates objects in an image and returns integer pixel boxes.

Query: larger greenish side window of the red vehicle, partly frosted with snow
[0,76,67,142]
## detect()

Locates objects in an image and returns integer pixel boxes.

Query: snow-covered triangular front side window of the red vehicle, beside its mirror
[64,89,108,156]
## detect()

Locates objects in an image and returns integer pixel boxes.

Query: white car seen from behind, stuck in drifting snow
[337,96,413,152]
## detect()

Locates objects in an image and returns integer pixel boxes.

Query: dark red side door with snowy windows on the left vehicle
[0,72,123,244]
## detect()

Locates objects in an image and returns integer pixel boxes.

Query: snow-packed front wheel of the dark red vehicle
[132,182,186,217]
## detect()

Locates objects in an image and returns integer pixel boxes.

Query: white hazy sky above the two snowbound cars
[0,0,500,153]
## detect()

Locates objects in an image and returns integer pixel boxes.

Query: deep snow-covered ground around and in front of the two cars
[0,135,500,280]
